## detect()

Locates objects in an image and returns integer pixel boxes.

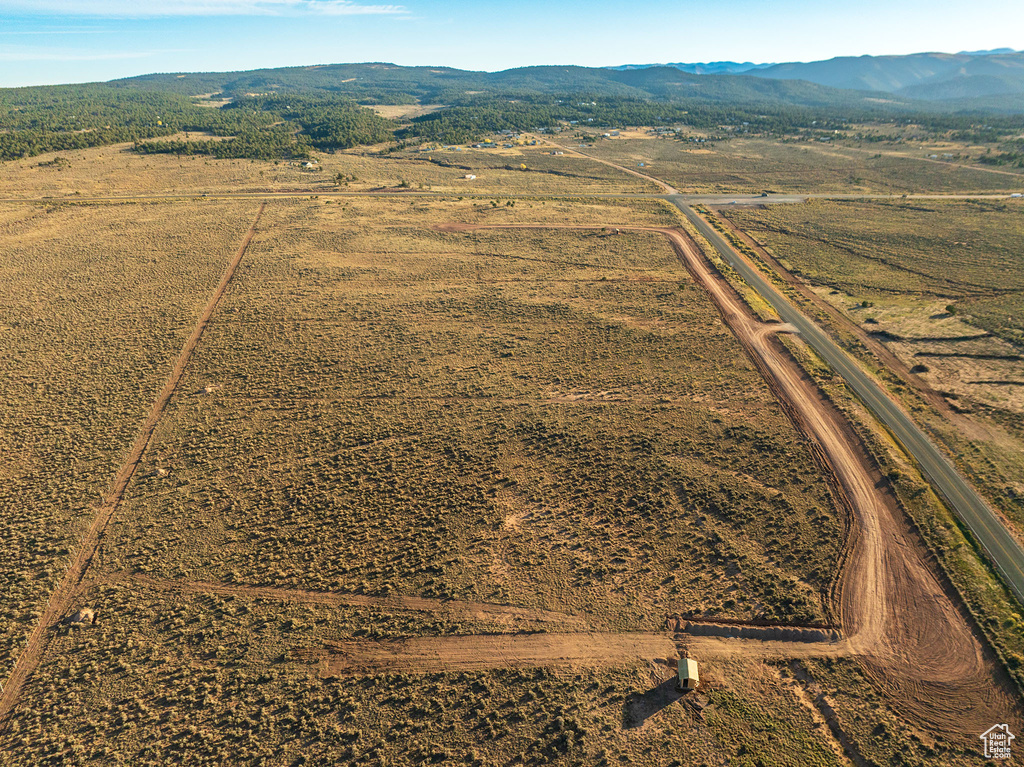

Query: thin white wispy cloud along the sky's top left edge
[0,0,409,18]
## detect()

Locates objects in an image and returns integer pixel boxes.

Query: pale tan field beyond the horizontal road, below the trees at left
[0,138,657,198]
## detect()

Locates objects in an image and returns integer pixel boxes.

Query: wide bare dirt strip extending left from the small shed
[314,634,677,676]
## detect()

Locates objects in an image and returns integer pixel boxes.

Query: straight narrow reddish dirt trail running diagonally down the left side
[0,203,266,723]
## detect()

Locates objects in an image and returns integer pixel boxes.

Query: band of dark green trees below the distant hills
[0,78,1024,164]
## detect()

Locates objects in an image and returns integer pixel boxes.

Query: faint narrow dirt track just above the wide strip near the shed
[116,573,589,630]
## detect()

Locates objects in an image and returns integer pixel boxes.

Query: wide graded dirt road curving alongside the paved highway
[434,224,1018,733]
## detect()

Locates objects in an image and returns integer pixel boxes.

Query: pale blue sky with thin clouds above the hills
[0,0,1024,86]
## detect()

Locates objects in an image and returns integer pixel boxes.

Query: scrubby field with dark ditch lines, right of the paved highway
[727,195,1024,525]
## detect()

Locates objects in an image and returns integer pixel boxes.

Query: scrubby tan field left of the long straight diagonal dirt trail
[0,203,264,676]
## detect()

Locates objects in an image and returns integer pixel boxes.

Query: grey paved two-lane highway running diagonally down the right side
[667,196,1024,604]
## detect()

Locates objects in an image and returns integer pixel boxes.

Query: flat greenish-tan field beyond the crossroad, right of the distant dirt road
[577,138,1024,194]
